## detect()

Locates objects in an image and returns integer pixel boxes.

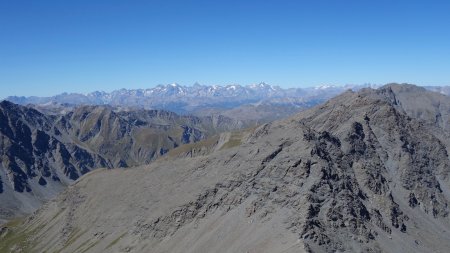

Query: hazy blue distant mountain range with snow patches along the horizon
[6,83,384,114]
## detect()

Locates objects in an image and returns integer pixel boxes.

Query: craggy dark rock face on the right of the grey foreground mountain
[284,86,450,252]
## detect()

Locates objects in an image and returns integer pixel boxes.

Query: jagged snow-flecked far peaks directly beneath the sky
[7,82,404,109]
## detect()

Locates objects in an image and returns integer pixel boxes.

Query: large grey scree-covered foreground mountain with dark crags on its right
[0,85,450,252]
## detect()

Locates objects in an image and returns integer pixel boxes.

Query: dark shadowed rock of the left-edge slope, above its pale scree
[0,101,107,192]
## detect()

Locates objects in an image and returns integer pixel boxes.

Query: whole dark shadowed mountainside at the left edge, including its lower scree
[0,101,110,221]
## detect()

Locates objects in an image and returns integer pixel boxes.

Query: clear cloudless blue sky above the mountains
[0,0,450,97]
